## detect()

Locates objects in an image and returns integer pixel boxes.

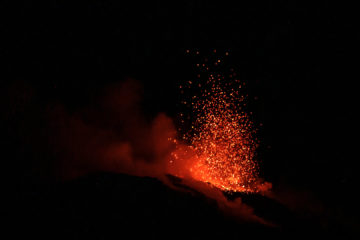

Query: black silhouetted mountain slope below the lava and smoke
[2,173,350,239]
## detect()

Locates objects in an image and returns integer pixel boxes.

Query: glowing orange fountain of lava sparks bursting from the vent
[170,51,259,192]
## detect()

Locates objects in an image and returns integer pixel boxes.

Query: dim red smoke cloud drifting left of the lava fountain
[45,79,175,179]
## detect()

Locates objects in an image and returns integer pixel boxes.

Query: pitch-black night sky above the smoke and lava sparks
[0,1,359,238]
